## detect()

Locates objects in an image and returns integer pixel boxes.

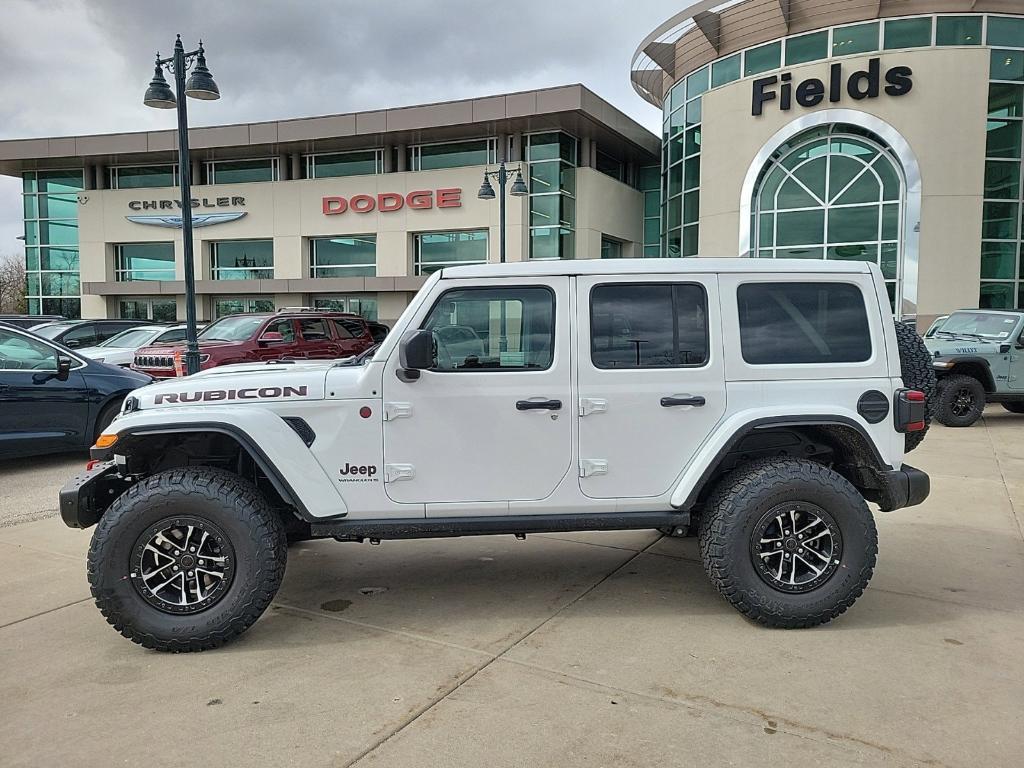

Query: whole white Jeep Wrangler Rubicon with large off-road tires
[60,259,935,651]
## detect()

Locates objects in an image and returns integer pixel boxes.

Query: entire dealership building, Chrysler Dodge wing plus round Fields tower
[0,0,1024,324]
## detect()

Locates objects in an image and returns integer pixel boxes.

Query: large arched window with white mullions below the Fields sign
[751,125,906,311]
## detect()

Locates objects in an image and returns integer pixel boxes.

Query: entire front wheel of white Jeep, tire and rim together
[88,467,288,652]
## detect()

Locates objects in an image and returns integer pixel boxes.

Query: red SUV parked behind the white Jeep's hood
[131,308,387,379]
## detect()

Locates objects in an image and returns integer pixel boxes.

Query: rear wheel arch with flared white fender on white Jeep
[672,415,893,511]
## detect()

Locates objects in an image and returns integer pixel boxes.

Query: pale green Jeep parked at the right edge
[925,309,1024,427]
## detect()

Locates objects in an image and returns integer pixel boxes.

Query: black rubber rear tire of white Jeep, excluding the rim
[699,459,878,629]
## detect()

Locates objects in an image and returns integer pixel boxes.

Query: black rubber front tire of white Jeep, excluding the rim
[88,467,288,652]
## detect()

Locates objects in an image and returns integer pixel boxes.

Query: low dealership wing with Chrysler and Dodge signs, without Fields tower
[0,85,660,323]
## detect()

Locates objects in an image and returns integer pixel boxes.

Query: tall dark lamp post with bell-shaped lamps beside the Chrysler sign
[142,35,220,375]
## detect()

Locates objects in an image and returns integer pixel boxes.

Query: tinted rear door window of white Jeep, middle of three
[590,283,708,369]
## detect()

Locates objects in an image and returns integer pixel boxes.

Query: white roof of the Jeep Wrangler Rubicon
[441,258,878,280]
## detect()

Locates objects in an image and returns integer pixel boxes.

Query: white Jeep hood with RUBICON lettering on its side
[135,360,334,411]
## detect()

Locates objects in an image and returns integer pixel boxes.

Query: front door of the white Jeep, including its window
[384,278,573,507]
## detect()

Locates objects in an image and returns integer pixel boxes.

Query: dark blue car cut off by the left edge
[0,327,153,458]
